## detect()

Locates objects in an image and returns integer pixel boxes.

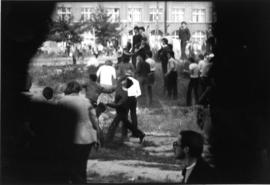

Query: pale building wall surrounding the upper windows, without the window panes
[55,1,212,44]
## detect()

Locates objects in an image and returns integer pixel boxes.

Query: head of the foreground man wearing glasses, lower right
[173,130,204,159]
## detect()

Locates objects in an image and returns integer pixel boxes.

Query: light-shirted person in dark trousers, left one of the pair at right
[186,58,199,106]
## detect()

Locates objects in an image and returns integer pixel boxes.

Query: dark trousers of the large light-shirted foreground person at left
[67,144,92,184]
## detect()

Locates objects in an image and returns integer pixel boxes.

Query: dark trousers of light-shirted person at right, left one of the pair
[187,78,199,106]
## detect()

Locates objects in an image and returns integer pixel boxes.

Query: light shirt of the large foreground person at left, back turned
[58,94,97,144]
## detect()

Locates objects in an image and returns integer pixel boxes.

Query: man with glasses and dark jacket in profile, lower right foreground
[173,130,217,184]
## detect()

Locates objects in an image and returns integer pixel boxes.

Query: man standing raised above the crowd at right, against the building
[179,21,190,60]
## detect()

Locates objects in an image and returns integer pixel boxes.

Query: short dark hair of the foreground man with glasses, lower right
[180,130,204,158]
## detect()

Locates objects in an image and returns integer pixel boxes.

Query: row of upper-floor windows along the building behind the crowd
[57,7,206,23]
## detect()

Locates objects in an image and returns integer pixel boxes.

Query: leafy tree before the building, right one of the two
[88,5,121,45]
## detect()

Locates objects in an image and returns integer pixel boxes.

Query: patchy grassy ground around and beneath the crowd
[30,57,209,183]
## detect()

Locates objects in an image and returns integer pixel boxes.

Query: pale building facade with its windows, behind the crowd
[56,1,213,47]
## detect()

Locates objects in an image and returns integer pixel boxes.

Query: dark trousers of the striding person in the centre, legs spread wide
[107,109,144,141]
